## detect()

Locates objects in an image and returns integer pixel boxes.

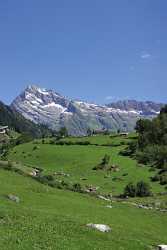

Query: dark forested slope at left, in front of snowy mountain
[0,102,50,138]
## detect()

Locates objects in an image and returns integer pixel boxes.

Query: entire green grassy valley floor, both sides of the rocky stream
[0,136,167,250]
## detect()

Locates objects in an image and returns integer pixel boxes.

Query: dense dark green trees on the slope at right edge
[130,105,167,185]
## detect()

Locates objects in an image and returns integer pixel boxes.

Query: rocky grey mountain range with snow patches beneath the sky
[11,85,164,135]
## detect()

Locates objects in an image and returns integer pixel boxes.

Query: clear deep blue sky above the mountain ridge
[0,0,167,103]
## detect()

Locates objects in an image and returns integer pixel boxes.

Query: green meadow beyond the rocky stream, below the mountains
[9,136,164,195]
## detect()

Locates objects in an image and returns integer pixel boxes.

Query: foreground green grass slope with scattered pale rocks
[0,169,167,250]
